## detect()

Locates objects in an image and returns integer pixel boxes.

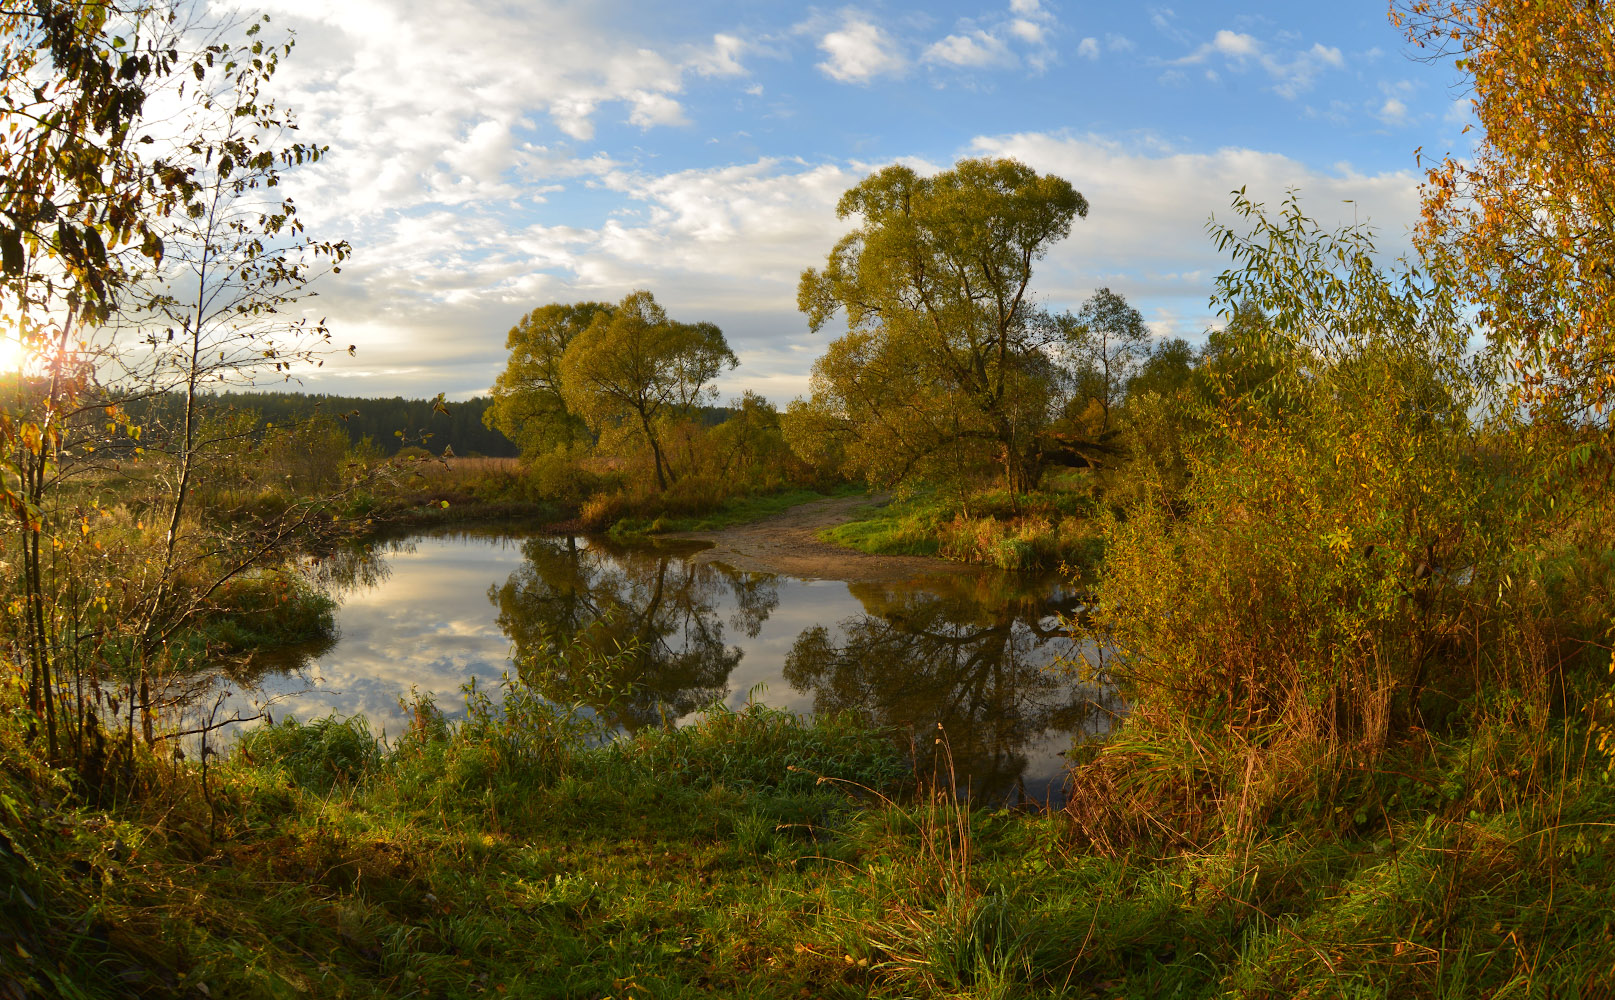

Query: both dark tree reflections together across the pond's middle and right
[489,538,1110,800]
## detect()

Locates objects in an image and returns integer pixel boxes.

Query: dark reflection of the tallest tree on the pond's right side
[785,575,1095,798]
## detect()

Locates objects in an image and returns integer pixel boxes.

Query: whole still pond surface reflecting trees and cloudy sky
[227,532,1116,801]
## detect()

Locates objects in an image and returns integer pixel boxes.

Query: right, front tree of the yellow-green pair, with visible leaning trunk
[560,291,740,489]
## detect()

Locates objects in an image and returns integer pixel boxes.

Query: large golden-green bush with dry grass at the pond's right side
[1072,195,1612,847]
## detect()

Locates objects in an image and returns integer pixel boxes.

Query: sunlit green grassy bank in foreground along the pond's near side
[0,675,1615,998]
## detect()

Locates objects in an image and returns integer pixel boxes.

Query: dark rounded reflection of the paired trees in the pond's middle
[488,538,778,732]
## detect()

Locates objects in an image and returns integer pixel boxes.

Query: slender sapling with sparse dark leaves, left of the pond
[116,18,352,738]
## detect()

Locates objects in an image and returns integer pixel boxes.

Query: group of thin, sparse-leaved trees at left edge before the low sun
[0,3,346,763]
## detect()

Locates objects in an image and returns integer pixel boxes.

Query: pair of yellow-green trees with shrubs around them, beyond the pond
[483,291,825,530]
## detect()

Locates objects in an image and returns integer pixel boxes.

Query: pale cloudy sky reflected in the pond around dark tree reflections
[221,533,1104,798]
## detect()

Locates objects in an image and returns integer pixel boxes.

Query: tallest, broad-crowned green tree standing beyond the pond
[787,160,1169,496]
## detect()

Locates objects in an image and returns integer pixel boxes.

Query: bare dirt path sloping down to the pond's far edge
[669,496,961,582]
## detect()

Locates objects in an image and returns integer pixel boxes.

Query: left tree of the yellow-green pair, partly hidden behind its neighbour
[483,302,612,457]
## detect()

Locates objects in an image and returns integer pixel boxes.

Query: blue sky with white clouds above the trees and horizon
[234,0,1470,405]
